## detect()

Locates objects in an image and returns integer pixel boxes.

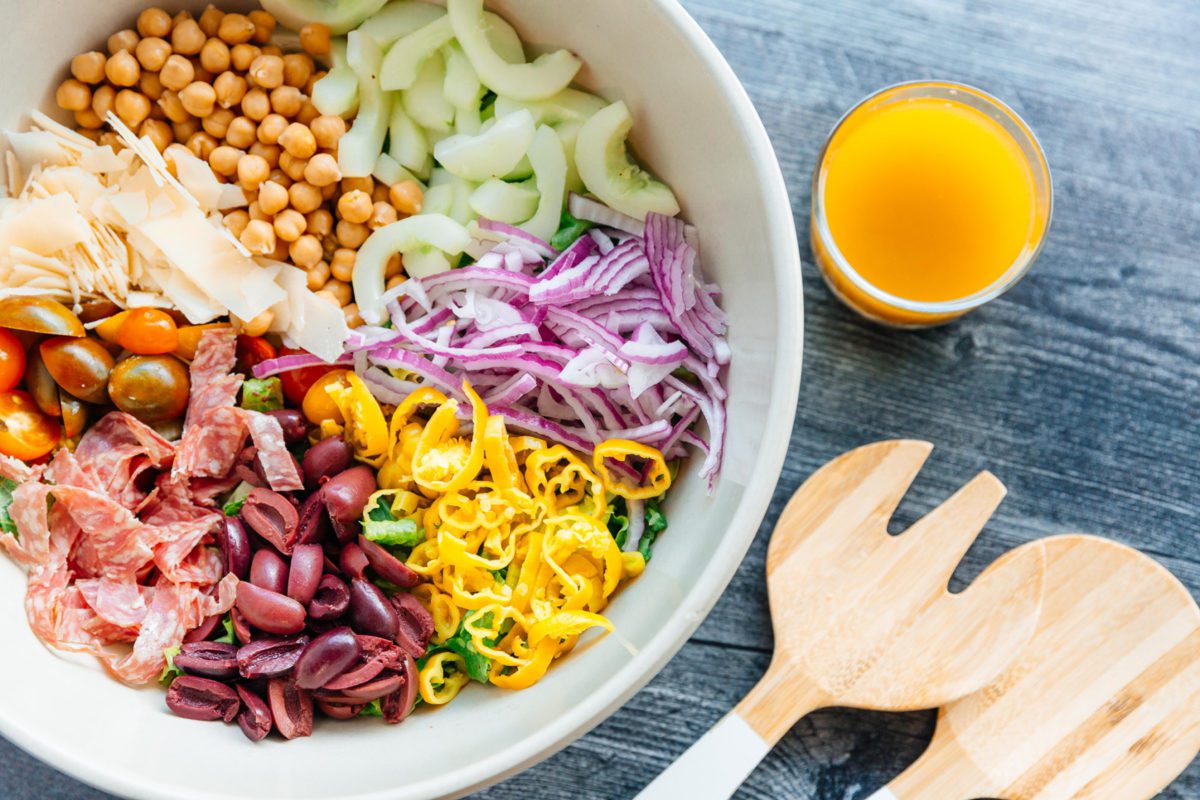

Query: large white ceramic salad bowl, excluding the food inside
[0,0,803,800]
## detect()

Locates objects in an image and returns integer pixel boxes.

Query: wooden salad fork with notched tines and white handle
[638,440,1045,800]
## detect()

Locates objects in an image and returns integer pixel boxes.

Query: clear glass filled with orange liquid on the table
[810,82,1054,327]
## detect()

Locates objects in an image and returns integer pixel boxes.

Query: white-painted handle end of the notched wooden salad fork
[635,711,770,800]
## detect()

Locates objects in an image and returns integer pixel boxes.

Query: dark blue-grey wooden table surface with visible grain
[0,0,1200,800]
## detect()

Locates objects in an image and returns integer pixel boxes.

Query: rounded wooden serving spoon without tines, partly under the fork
[870,535,1200,800]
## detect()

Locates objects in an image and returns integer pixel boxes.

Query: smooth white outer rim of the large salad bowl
[0,0,804,800]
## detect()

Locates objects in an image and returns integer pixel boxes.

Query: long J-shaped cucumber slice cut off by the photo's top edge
[446,0,583,100]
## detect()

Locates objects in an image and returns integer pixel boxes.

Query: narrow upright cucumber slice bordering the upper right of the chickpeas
[337,31,392,178]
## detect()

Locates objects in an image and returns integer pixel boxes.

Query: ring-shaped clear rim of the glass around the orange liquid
[811,79,1054,314]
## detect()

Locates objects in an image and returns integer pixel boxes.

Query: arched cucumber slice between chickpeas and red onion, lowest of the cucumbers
[353,213,470,325]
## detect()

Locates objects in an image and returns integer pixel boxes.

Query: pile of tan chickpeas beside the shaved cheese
[56,5,424,335]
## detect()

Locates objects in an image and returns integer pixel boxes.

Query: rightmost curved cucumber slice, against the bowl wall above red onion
[575,101,679,219]
